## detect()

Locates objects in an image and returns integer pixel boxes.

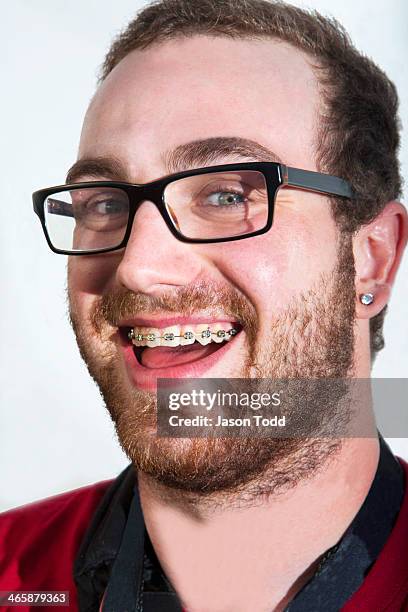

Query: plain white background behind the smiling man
[0,0,408,509]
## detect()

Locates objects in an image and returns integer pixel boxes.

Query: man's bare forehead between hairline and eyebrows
[79,36,320,176]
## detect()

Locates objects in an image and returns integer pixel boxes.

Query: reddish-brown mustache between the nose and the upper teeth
[90,281,258,336]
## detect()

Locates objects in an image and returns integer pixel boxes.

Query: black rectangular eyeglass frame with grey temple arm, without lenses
[32,162,353,257]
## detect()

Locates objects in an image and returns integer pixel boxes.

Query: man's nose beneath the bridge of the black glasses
[116,201,204,295]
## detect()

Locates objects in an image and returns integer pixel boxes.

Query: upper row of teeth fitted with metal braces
[128,323,238,347]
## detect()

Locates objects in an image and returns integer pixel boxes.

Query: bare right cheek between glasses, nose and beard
[207,194,337,317]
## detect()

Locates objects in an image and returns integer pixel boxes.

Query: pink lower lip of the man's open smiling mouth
[118,326,239,392]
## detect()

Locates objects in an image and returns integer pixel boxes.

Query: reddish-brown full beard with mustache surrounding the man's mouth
[68,234,355,506]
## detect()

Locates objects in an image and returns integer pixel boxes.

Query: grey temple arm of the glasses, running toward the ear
[281,164,353,198]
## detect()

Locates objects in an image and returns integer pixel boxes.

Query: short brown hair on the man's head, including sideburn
[99,0,401,362]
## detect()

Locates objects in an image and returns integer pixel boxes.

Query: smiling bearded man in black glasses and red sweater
[0,0,408,612]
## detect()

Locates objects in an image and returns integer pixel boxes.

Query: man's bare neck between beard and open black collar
[138,438,379,612]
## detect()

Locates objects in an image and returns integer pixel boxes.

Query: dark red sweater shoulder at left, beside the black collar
[0,480,112,590]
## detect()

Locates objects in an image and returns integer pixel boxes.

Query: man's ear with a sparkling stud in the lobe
[353,202,408,319]
